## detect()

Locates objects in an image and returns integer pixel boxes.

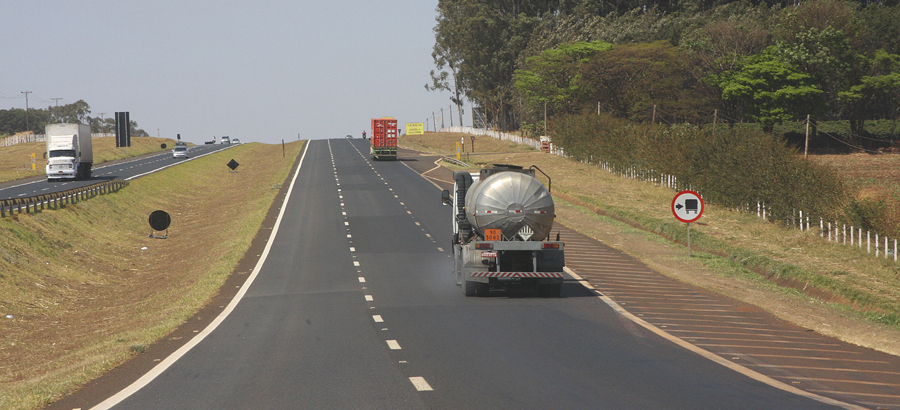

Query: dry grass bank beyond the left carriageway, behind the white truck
[0,137,181,182]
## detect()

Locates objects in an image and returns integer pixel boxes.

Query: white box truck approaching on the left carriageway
[45,124,94,181]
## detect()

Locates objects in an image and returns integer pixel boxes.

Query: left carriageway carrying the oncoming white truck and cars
[0,144,234,199]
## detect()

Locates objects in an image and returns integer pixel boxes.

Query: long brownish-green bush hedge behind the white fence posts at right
[550,115,848,218]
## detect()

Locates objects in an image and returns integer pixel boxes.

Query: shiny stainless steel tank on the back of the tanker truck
[466,171,556,241]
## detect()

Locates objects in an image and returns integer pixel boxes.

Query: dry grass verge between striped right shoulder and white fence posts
[400,134,900,354]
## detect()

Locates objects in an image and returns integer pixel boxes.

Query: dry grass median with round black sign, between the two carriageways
[0,143,302,409]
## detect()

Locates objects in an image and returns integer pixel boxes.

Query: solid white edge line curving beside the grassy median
[91,140,309,410]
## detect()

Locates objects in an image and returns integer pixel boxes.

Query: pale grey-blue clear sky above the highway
[0,0,471,144]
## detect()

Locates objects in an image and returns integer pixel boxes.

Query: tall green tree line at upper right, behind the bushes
[426,0,900,139]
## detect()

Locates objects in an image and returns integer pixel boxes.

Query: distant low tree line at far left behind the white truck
[0,100,150,137]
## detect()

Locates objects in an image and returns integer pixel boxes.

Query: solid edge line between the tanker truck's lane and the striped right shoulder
[563,266,866,410]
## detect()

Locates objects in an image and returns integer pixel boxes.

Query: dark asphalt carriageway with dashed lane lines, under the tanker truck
[77,139,834,409]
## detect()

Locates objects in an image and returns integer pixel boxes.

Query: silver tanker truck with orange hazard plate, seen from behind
[441,164,565,297]
